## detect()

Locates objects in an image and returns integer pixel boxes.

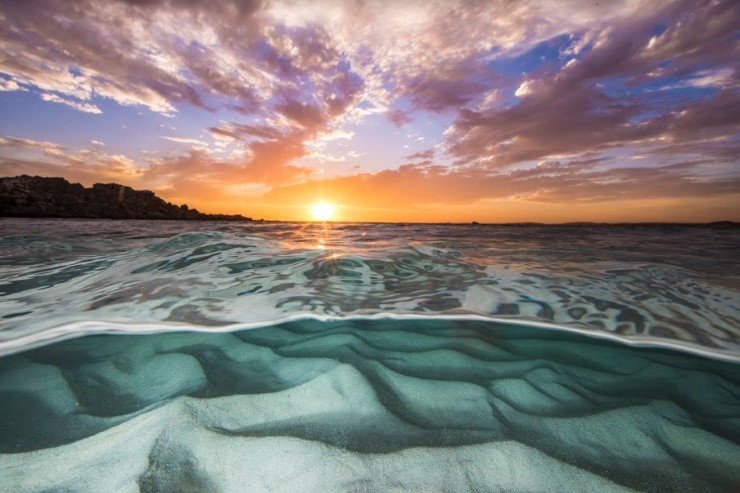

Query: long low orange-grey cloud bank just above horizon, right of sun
[266,151,740,208]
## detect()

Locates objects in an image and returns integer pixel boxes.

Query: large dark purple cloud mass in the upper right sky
[446,2,740,167]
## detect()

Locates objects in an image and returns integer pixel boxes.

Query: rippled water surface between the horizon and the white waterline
[0,219,740,357]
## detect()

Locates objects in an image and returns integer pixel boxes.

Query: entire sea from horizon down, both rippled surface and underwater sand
[0,219,740,492]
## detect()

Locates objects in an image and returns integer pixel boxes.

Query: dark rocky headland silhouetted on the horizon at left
[0,175,252,221]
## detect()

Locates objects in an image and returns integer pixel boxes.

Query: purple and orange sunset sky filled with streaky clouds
[0,0,740,223]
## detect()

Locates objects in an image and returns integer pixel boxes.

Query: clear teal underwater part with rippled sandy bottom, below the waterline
[0,320,740,491]
